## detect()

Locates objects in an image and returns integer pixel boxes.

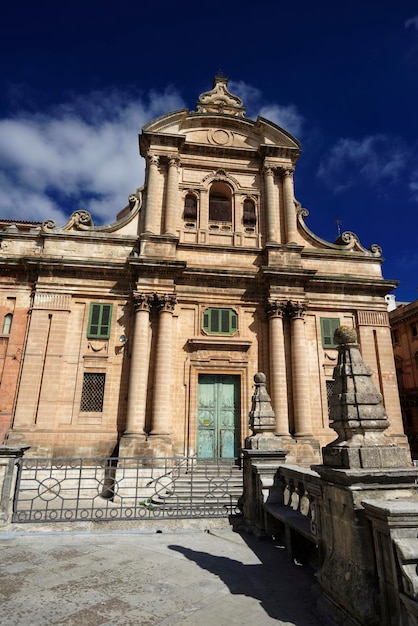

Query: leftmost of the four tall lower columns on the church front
[124,293,154,436]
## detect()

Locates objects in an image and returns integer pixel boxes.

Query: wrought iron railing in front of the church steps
[13,457,242,523]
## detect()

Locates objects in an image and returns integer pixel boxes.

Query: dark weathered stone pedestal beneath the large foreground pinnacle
[312,465,418,626]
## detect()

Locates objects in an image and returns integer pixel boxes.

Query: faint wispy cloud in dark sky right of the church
[317,135,410,193]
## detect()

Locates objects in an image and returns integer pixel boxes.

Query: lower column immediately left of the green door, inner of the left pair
[151,293,177,435]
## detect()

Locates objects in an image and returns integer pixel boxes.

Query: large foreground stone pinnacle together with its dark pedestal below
[312,327,418,626]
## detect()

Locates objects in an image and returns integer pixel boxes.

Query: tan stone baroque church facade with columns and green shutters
[0,76,406,463]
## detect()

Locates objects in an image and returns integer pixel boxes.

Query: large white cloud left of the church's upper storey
[0,89,184,224]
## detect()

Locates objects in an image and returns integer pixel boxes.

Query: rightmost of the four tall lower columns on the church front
[288,302,312,437]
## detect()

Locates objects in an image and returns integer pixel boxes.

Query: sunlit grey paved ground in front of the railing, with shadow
[0,529,330,626]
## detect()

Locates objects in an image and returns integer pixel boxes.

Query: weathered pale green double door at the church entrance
[197,374,240,459]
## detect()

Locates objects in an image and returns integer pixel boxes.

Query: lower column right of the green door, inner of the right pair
[267,300,289,437]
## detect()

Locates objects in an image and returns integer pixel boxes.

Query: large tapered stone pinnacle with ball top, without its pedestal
[322,326,409,469]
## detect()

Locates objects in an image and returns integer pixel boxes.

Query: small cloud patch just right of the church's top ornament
[228,80,304,138]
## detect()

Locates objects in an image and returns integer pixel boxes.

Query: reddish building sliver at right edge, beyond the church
[389,300,418,459]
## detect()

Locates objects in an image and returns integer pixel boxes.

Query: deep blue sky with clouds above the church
[0,0,418,301]
